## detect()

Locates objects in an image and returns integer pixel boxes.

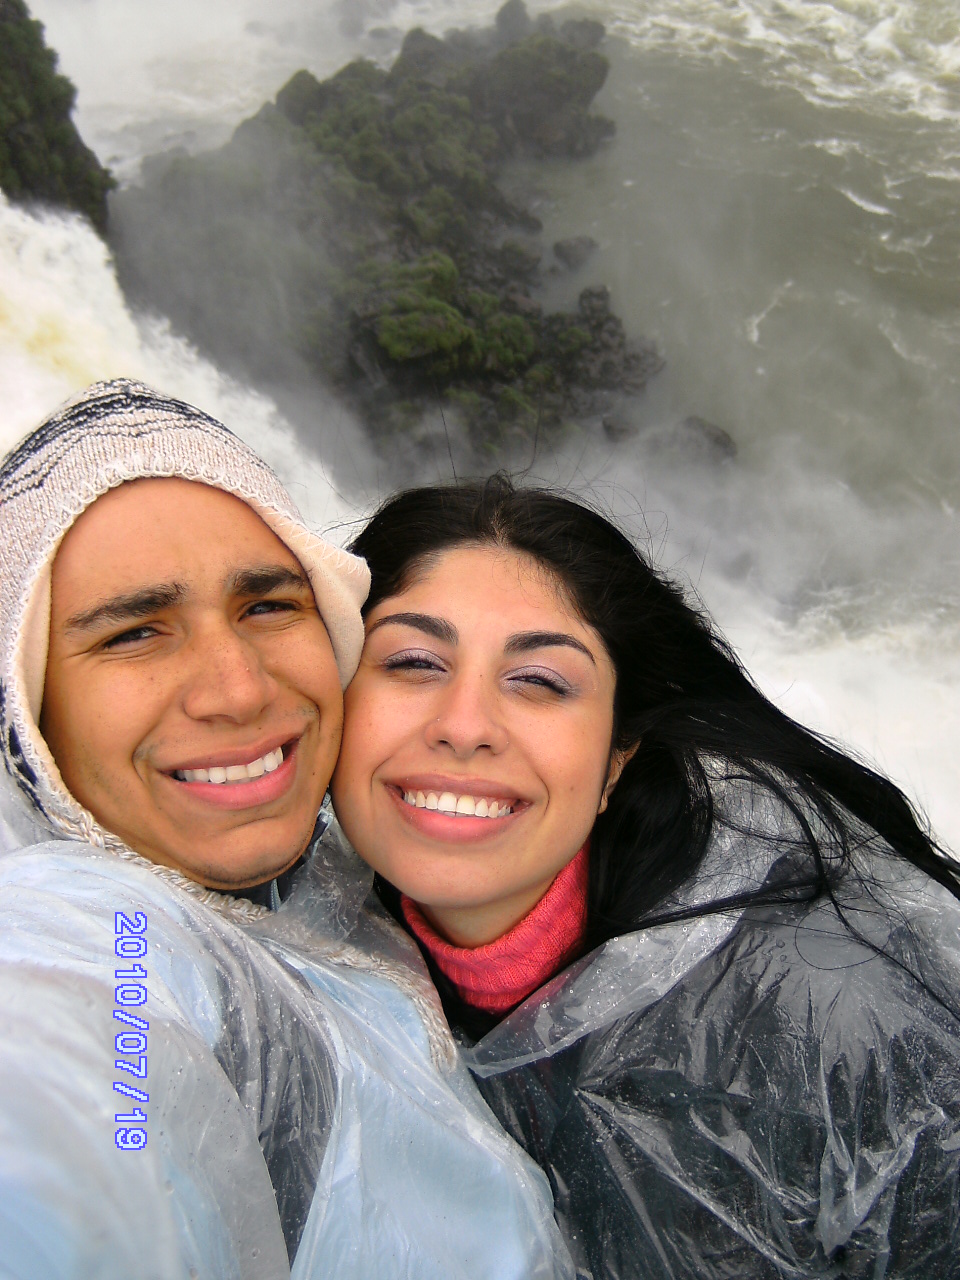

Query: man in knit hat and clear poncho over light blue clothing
[0,381,572,1280]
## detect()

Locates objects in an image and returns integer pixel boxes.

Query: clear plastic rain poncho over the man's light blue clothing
[0,791,573,1280]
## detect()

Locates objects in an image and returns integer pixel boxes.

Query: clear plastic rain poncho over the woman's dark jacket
[440,783,960,1280]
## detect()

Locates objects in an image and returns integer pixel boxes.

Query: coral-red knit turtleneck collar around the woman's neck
[401,845,588,1014]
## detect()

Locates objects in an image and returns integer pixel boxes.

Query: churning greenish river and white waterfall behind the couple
[0,0,960,849]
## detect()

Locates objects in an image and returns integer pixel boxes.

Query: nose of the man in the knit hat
[183,621,278,723]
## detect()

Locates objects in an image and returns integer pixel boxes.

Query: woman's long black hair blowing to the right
[351,475,960,945]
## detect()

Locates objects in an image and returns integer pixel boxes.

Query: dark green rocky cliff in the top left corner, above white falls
[0,0,114,232]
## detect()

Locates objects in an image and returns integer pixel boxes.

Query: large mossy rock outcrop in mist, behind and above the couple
[108,0,655,457]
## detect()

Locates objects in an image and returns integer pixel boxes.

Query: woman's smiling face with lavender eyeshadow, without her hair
[333,545,620,946]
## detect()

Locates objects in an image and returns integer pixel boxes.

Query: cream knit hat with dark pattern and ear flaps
[0,380,370,852]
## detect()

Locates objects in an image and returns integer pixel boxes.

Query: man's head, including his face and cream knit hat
[0,383,369,890]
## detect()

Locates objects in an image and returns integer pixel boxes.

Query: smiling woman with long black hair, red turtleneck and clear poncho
[333,476,960,1280]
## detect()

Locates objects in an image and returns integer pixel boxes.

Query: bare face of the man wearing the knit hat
[40,479,343,888]
